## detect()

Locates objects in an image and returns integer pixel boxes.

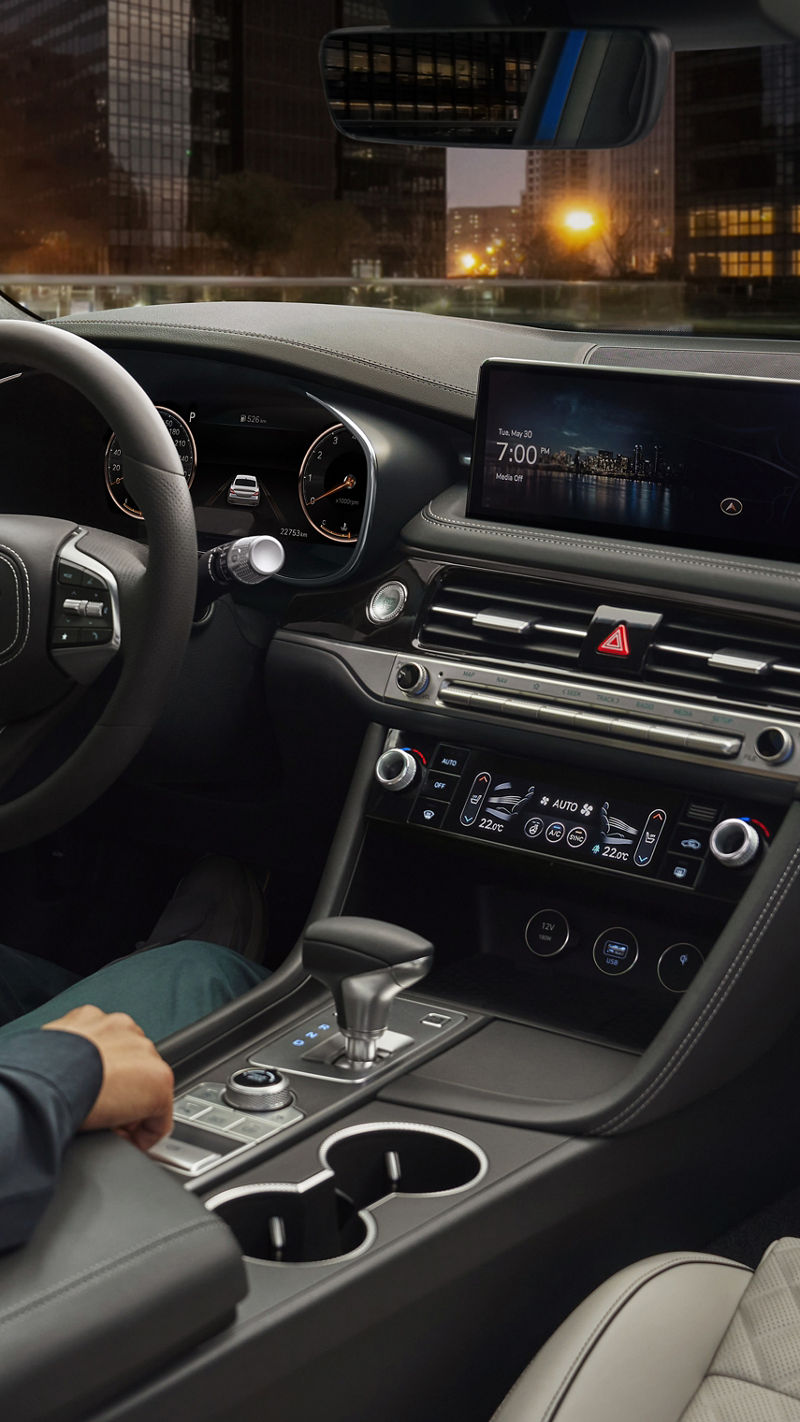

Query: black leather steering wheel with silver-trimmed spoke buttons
[0,320,198,850]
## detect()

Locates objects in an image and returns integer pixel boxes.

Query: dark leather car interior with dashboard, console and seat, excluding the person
[0,0,800,1422]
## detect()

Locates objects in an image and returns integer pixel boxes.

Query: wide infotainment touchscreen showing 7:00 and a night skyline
[467,360,800,559]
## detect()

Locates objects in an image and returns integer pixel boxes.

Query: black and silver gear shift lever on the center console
[303,919,433,1067]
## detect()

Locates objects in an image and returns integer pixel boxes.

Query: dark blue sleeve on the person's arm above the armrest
[0,1030,102,1251]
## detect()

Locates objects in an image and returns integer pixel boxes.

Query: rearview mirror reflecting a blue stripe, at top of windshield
[320,28,671,148]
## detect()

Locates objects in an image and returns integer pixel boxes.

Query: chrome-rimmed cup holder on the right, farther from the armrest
[320,1125,487,1210]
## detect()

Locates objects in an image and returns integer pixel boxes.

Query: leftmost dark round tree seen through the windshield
[198,172,298,274]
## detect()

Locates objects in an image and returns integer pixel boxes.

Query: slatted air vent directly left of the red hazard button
[418,570,597,671]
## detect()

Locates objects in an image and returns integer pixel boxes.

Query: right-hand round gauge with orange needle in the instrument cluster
[300,425,367,543]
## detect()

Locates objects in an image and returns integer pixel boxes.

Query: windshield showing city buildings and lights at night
[0,0,800,336]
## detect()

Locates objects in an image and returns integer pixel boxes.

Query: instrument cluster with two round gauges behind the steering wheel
[0,357,375,580]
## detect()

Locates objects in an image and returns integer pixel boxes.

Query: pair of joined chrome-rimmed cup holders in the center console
[206,1123,489,1264]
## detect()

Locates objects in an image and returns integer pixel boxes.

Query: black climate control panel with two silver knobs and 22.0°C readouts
[369,731,780,899]
